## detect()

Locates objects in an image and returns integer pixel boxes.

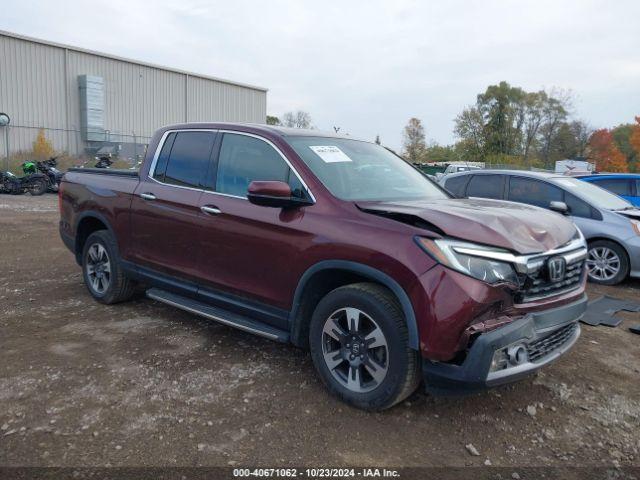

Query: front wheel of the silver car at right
[587,240,630,285]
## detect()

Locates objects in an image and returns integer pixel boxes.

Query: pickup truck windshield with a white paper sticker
[286,137,448,201]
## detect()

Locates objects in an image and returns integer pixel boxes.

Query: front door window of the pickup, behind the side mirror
[216,133,304,197]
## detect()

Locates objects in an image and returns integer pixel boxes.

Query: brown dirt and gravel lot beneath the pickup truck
[0,195,640,472]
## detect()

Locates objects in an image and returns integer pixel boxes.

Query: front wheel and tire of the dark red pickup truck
[309,283,420,411]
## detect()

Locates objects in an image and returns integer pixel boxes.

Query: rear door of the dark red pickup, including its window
[131,130,216,281]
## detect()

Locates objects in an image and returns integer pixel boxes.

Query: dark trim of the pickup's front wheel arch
[289,260,419,350]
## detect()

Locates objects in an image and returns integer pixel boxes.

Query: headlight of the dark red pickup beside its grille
[416,237,518,286]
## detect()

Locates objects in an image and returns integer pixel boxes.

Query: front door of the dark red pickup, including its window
[198,132,313,320]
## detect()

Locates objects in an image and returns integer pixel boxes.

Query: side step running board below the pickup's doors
[147,288,289,343]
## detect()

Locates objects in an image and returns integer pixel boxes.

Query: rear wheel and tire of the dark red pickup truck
[82,230,135,305]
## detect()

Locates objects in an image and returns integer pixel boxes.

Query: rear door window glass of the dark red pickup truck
[159,132,215,188]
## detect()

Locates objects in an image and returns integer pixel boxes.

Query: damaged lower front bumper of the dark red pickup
[422,295,587,395]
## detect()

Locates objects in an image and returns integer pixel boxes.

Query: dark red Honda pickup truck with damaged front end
[60,123,586,409]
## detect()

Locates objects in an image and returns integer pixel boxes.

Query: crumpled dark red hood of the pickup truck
[357,198,576,254]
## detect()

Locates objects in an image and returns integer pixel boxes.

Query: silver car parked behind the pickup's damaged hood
[440,170,640,285]
